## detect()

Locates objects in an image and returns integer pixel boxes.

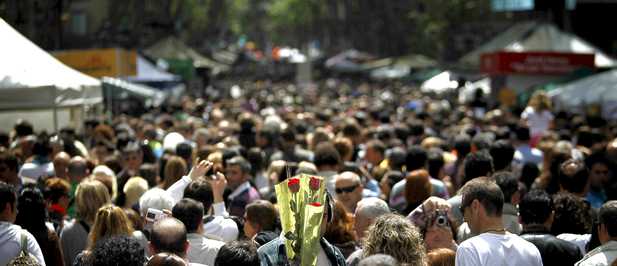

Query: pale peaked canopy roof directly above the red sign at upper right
[459,22,617,68]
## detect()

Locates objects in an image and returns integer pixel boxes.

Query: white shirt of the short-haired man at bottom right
[456,233,542,266]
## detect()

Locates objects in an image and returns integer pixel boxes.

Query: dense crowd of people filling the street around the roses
[0,80,617,266]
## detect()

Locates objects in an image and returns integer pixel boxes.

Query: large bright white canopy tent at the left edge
[0,19,103,130]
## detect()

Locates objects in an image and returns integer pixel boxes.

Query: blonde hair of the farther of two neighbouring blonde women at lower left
[75,179,111,223]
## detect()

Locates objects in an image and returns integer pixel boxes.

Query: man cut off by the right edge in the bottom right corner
[575,200,617,266]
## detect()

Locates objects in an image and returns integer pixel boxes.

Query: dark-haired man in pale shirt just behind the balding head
[171,199,225,265]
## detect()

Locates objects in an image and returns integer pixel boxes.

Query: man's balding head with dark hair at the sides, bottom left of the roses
[148,218,203,266]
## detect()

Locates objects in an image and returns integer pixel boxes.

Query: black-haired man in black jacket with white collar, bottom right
[519,190,583,265]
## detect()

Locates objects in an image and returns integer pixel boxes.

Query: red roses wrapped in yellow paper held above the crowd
[275,174,326,265]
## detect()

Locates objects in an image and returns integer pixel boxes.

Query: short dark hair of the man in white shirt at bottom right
[460,177,503,216]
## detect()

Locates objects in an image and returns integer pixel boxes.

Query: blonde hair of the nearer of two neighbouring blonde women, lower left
[88,204,133,250]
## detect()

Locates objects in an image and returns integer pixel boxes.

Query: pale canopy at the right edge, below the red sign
[548,69,617,119]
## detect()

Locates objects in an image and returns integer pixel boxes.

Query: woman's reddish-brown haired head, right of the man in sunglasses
[403,170,433,215]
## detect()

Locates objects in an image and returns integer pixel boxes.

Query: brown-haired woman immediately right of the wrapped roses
[324,201,356,258]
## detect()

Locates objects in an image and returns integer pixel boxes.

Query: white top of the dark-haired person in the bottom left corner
[0,222,45,266]
